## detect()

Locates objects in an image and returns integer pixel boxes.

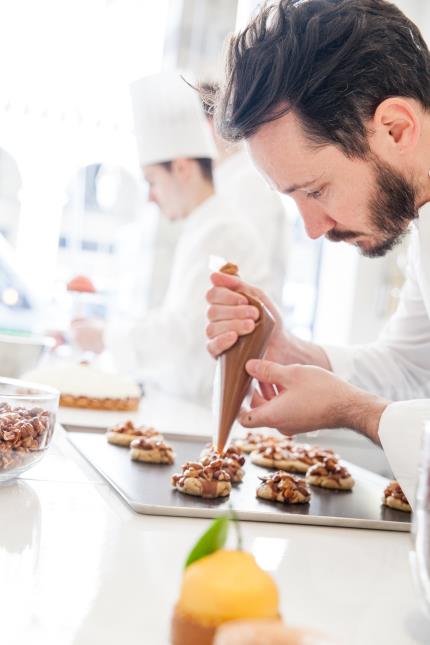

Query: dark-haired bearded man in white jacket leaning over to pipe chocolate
[207,0,430,504]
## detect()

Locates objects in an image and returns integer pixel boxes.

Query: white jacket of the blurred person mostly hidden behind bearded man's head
[214,150,290,305]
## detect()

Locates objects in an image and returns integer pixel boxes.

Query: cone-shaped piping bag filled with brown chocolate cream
[213,263,275,452]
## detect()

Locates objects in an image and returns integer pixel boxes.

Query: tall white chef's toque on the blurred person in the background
[130,72,216,166]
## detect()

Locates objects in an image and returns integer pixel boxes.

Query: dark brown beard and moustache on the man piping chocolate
[326,157,418,258]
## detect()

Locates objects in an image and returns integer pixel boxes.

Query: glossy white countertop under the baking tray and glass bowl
[0,390,430,645]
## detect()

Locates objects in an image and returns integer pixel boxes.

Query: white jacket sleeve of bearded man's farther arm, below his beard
[324,231,430,401]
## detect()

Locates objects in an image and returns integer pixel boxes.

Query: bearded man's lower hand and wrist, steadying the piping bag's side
[239,360,388,443]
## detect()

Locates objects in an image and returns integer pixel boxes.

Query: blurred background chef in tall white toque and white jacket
[73,73,270,403]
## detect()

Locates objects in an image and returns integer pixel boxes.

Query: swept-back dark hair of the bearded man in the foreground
[215,0,430,157]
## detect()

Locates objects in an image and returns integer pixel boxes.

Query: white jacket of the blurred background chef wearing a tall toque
[106,195,270,403]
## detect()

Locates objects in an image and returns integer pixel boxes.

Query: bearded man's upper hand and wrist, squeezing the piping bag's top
[206,273,330,369]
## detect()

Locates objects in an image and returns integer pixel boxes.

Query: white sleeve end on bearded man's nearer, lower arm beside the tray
[379,399,430,508]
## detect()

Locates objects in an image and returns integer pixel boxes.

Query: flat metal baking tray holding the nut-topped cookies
[67,431,411,531]
